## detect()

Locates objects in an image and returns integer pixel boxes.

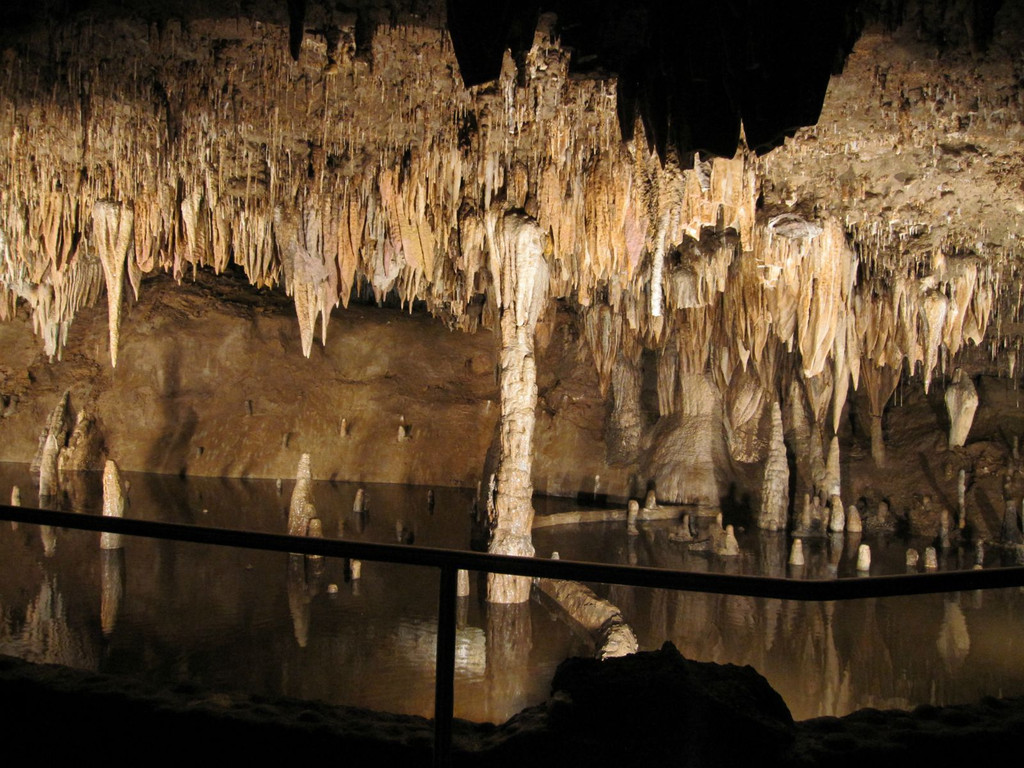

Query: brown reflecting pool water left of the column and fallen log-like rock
[0,467,582,721]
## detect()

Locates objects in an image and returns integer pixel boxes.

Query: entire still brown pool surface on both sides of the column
[0,465,1024,722]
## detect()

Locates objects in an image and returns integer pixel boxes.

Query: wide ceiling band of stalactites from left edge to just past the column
[0,15,770,362]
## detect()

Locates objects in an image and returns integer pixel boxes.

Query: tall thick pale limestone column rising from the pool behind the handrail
[486,214,548,603]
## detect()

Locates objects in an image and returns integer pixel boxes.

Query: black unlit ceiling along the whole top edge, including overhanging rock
[0,0,1002,163]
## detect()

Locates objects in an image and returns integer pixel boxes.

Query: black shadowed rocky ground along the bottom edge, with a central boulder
[0,643,1024,768]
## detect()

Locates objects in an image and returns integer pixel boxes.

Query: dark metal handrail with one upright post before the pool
[6,505,1024,765]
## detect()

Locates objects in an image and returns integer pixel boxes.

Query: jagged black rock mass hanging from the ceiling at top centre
[447,0,862,159]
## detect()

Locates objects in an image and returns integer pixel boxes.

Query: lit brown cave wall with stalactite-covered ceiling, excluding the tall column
[0,2,1024,518]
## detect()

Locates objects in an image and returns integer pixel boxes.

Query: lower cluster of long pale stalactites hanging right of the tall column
[583,201,999,462]
